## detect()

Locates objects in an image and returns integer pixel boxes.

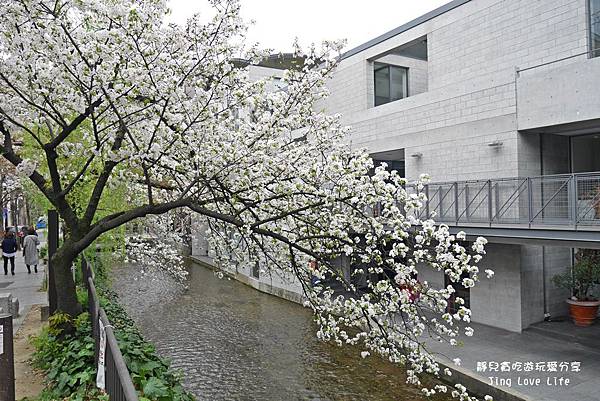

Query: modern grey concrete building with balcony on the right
[193,0,600,332]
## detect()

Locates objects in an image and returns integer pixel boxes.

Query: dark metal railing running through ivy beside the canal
[81,259,138,401]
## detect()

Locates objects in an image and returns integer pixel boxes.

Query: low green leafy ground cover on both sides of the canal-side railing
[33,253,194,401]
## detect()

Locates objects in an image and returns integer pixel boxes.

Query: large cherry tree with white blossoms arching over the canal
[0,0,491,398]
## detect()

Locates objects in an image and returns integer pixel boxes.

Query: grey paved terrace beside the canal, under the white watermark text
[429,323,600,401]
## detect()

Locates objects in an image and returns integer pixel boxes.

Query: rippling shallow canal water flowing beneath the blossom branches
[113,266,450,401]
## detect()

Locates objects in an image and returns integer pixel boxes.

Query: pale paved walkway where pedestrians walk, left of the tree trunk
[0,251,48,333]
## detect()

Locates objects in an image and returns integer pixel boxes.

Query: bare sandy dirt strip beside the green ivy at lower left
[14,305,46,400]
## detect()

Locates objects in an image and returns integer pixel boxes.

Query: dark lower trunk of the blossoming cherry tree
[50,242,83,317]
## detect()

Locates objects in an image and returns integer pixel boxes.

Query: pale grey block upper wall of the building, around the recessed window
[320,0,587,181]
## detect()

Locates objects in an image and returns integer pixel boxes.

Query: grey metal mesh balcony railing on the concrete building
[409,172,600,230]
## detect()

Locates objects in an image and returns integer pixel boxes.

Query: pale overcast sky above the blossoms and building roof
[170,0,449,52]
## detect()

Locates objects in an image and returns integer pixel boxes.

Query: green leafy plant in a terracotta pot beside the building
[552,249,600,327]
